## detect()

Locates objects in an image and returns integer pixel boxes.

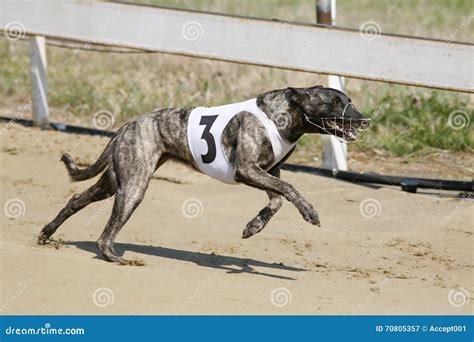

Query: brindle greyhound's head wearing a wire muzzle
[288,86,370,141]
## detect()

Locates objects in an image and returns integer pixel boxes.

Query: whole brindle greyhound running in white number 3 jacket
[38,86,370,265]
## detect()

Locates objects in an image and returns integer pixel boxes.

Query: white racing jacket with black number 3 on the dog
[187,99,296,184]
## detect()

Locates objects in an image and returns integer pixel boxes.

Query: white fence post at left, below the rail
[29,36,49,127]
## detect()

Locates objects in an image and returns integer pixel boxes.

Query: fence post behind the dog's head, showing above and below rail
[316,0,347,171]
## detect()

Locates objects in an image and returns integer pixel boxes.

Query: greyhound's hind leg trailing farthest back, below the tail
[38,170,117,244]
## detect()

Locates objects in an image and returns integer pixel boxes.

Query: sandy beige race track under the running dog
[0,125,474,315]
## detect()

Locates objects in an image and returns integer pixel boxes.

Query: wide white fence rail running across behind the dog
[0,0,474,93]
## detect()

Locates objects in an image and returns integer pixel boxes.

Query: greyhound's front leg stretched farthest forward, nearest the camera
[235,163,321,226]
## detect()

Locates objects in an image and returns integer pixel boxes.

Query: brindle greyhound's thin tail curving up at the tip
[61,139,114,182]
